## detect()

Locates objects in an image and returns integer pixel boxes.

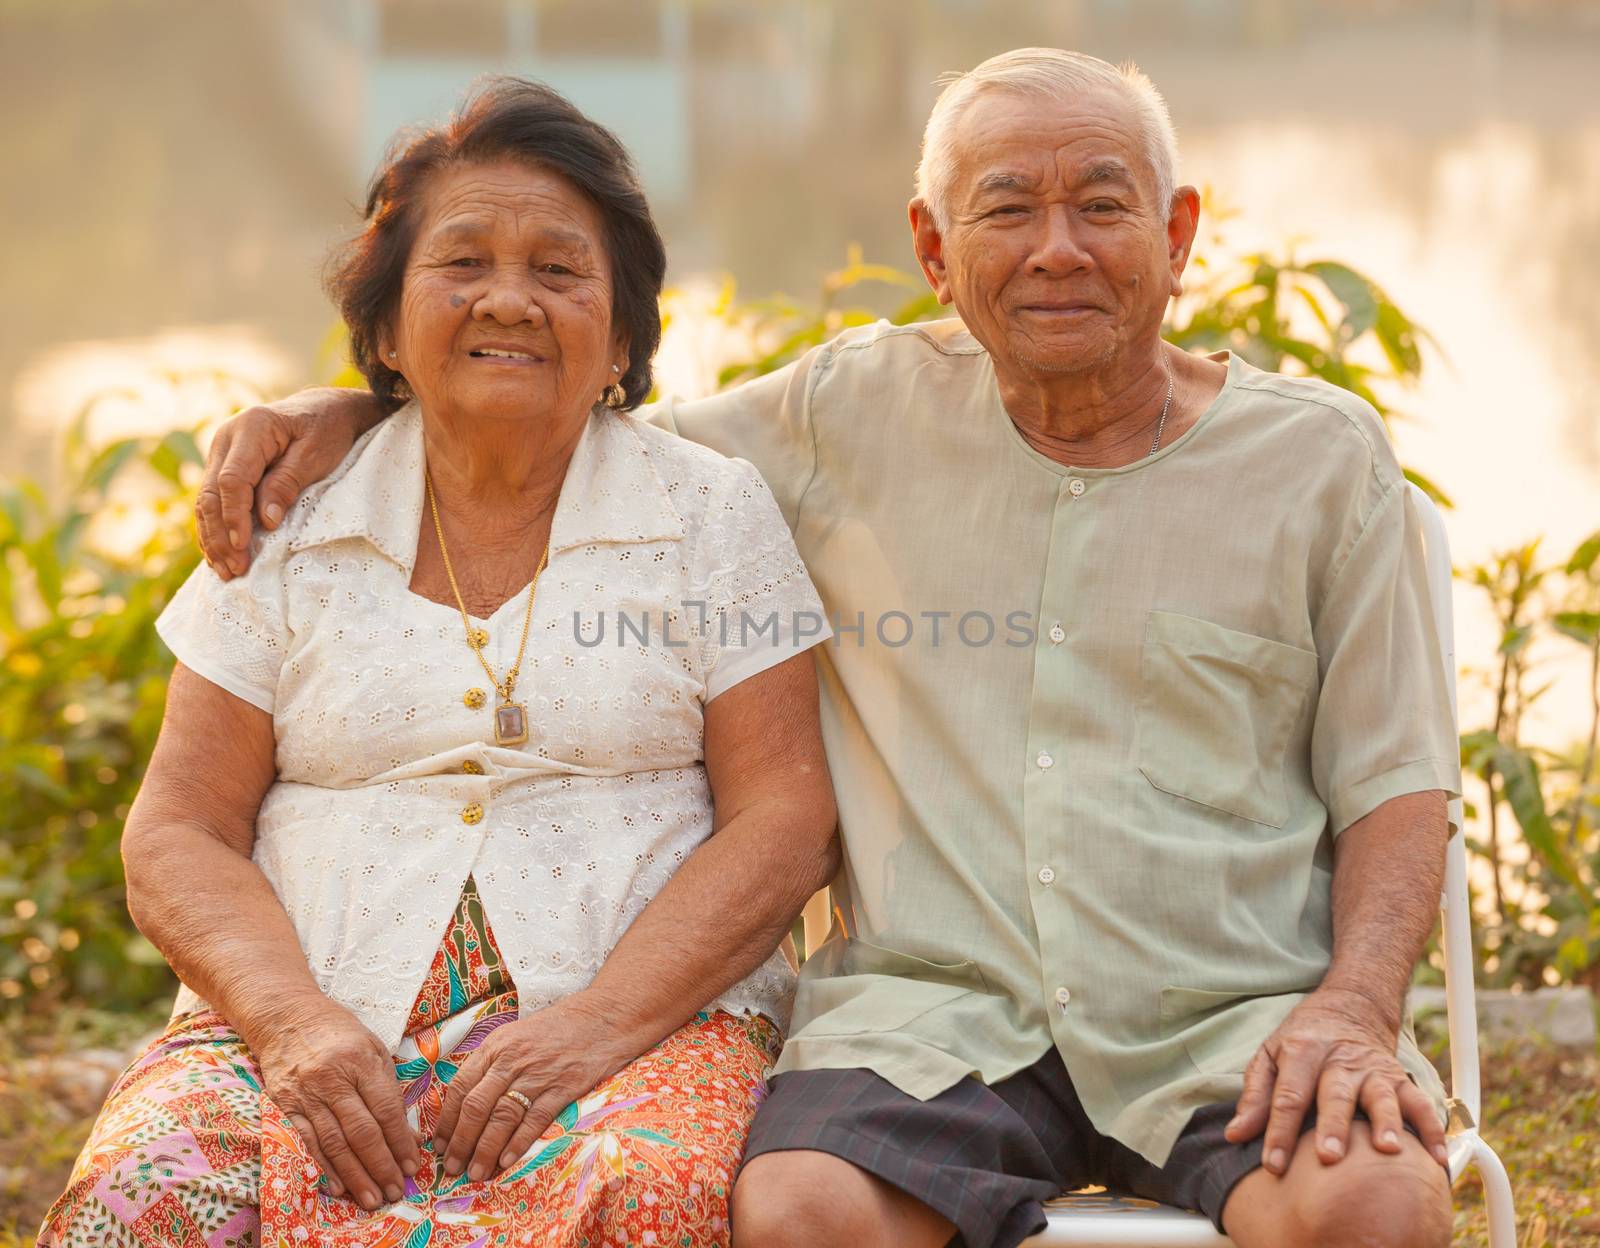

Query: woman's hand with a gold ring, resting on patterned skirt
[434,994,617,1182]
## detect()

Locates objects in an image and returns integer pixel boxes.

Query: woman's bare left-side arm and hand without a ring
[122,664,418,1208]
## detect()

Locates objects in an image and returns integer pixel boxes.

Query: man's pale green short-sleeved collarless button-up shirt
[654,322,1459,1163]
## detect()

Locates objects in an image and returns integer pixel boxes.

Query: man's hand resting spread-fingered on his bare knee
[1227,987,1446,1174]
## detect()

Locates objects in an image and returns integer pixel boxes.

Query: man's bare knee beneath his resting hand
[1293,1146,1451,1248]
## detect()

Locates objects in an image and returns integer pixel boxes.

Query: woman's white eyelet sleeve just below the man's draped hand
[155,533,290,714]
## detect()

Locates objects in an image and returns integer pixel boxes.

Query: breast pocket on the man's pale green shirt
[1136,611,1317,827]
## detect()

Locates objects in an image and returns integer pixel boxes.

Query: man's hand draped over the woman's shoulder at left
[195,386,382,581]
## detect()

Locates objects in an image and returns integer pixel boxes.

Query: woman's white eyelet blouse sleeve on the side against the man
[690,459,834,702]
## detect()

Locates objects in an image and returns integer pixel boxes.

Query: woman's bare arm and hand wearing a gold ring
[435,653,838,1178]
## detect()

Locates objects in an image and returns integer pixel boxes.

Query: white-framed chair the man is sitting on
[805,485,1517,1248]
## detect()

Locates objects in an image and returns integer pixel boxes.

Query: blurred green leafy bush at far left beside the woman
[0,404,219,1010]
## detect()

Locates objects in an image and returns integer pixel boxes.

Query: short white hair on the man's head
[917,48,1178,230]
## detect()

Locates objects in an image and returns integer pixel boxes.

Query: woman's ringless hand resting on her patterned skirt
[251,1002,421,1210]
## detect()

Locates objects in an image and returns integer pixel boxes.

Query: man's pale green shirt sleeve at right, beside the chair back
[1312,480,1461,835]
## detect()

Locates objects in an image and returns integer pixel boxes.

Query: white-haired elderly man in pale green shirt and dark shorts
[200,50,1459,1248]
